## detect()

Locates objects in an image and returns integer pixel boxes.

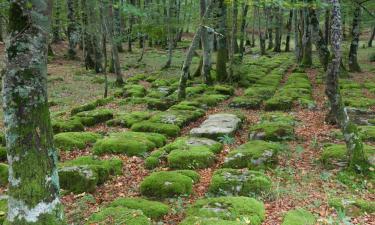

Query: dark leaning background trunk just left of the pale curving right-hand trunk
[309,8,330,71]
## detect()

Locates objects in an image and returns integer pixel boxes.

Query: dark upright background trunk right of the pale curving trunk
[349,4,361,72]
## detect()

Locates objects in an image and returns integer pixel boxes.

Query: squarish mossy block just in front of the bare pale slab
[167,146,215,169]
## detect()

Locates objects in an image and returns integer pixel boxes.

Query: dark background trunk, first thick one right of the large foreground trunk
[66,0,79,59]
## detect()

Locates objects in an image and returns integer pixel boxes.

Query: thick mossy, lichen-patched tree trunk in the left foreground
[3,0,66,225]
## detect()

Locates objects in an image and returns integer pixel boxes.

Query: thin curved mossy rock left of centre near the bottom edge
[109,198,170,220]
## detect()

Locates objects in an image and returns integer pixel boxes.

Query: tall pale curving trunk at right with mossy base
[326,0,369,172]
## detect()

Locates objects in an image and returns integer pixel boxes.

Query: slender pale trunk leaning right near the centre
[178,2,214,100]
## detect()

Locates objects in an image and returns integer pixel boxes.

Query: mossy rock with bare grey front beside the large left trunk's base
[59,156,122,193]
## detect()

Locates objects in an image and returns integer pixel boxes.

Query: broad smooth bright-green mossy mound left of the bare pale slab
[93,132,167,156]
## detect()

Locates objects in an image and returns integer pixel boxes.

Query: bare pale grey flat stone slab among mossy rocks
[190,113,241,139]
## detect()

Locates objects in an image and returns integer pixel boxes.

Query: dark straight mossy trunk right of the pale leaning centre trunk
[215,0,228,82]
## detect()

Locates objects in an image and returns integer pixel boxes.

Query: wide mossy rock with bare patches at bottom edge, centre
[186,197,265,225]
